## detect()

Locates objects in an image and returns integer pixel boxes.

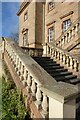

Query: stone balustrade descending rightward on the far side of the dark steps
[46,43,80,72]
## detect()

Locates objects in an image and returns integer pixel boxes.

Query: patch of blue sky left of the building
[0,2,19,37]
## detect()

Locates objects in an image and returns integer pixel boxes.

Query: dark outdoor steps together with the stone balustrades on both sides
[3,38,80,120]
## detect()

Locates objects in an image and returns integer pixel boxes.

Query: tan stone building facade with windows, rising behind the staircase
[17,1,80,54]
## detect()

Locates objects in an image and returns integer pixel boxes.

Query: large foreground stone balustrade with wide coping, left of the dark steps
[4,38,79,118]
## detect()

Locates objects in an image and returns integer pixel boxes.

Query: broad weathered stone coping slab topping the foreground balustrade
[4,38,80,103]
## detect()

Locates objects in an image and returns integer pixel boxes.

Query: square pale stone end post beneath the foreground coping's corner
[49,97,76,119]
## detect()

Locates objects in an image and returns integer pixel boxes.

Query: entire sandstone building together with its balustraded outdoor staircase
[2,0,80,120]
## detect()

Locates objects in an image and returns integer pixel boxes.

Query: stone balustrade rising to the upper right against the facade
[54,17,80,47]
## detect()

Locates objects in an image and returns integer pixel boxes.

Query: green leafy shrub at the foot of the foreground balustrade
[2,77,27,120]
